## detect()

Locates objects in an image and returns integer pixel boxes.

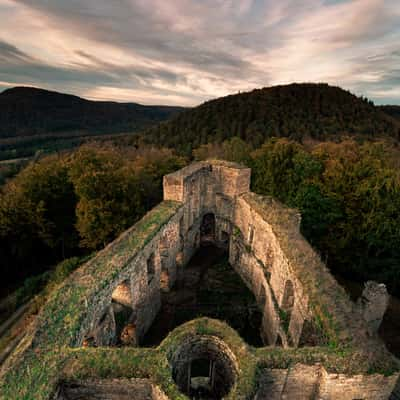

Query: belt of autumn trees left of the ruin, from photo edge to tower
[0,144,186,290]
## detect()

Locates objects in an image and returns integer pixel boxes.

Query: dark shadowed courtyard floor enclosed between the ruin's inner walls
[140,214,263,346]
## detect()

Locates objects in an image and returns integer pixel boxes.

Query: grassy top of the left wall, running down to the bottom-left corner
[0,201,180,400]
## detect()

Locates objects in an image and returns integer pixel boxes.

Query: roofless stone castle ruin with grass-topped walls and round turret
[0,161,399,400]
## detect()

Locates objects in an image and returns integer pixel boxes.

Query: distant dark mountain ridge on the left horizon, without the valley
[0,87,183,138]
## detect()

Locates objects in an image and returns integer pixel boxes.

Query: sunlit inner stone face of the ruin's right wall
[230,197,310,346]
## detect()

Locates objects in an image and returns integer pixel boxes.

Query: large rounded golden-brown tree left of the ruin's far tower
[69,146,144,249]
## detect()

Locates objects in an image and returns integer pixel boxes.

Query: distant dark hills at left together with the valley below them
[0,87,183,164]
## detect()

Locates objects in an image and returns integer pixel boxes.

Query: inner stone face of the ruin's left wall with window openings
[76,209,184,346]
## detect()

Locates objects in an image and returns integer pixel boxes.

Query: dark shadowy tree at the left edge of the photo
[0,156,77,254]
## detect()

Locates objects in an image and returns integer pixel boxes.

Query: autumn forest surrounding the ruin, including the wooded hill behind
[0,85,400,306]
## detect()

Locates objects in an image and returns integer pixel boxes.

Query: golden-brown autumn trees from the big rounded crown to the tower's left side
[69,145,185,249]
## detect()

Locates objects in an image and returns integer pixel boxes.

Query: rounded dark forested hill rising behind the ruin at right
[143,83,400,153]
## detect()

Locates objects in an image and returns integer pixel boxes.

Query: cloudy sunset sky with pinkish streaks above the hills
[0,0,400,106]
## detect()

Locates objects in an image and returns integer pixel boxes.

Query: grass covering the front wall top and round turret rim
[0,318,396,400]
